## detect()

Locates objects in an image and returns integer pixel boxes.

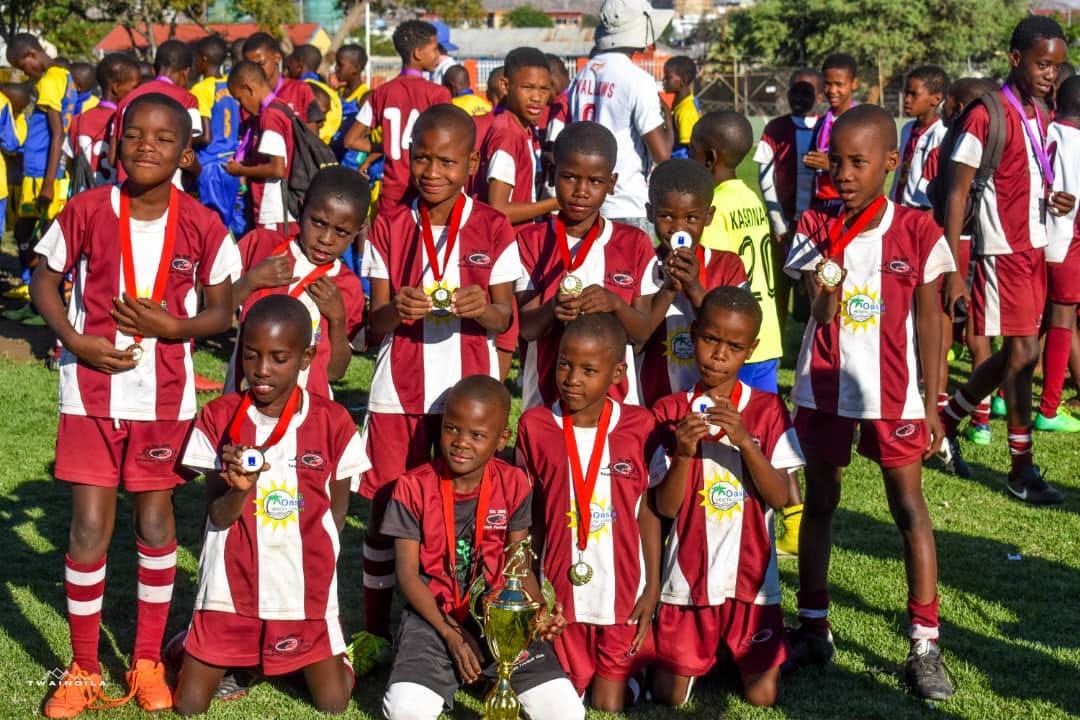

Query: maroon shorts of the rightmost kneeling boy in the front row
[657,600,789,678]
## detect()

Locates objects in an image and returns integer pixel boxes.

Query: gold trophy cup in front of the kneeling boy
[469,538,555,720]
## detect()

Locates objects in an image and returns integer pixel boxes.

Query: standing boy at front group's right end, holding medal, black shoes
[785,105,955,699]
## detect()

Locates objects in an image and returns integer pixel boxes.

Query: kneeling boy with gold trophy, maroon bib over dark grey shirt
[382,377,585,720]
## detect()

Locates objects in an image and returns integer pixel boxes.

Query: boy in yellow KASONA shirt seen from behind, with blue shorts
[691,108,802,555]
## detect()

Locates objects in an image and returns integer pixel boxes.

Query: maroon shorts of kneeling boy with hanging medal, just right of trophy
[552,623,654,693]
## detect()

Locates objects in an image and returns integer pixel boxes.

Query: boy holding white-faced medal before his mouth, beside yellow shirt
[640,160,747,407]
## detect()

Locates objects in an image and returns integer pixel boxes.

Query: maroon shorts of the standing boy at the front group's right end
[793,407,930,470]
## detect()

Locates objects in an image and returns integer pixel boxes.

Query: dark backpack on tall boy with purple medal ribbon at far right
[927,92,1007,235]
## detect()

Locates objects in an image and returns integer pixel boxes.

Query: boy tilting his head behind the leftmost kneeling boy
[227,165,370,397]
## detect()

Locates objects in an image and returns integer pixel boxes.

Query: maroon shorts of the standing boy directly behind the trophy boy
[360,412,443,499]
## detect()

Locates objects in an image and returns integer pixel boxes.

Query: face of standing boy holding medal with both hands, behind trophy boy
[409,126,480,205]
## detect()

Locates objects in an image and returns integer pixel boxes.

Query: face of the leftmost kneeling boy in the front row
[240,322,315,408]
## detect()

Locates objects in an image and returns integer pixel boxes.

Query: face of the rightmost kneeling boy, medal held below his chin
[691,309,757,390]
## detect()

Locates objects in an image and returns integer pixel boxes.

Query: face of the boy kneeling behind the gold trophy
[438,395,510,477]
